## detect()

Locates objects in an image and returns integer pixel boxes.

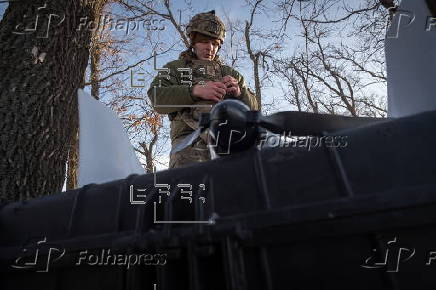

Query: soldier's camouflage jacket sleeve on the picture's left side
[147,63,196,114]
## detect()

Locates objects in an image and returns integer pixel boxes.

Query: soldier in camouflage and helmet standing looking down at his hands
[147,10,259,168]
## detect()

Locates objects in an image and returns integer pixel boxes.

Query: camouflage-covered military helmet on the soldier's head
[186,10,226,43]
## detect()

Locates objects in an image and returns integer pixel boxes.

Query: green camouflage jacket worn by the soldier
[147,51,259,145]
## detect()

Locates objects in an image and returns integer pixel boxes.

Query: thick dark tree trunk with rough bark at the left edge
[0,0,100,201]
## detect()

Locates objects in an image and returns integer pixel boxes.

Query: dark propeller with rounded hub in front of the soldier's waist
[171,98,388,159]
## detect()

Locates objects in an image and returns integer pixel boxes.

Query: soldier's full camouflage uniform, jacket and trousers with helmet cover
[147,13,258,168]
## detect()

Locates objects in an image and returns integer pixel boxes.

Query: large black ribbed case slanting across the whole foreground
[0,112,436,290]
